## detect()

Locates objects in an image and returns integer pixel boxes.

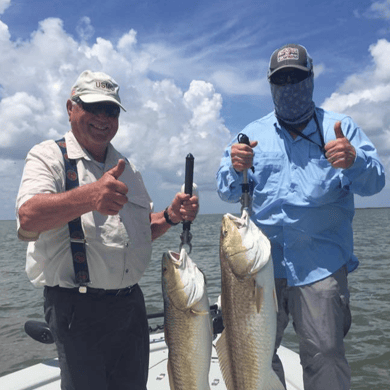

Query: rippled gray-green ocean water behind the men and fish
[0,212,390,390]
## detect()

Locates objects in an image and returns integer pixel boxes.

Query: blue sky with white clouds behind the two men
[0,0,390,219]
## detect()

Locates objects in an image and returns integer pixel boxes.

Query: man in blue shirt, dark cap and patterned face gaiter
[217,44,385,390]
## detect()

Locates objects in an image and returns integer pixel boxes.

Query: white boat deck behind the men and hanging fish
[0,333,303,390]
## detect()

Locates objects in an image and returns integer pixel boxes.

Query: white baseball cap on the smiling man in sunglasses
[70,70,126,111]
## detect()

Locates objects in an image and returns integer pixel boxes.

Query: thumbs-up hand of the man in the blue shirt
[325,121,356,169]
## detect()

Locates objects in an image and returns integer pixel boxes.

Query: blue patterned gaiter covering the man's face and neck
[270,74,315,125]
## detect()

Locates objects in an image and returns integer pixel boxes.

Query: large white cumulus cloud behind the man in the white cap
[0,15,231,218]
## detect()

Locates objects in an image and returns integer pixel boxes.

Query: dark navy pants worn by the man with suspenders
[44,285,149,390]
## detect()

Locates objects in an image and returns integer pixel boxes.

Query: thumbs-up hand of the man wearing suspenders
[93,159,128,215]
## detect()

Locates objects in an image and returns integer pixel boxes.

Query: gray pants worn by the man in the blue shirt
[272,267,351,390]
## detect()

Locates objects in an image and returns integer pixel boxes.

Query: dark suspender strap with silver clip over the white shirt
[56,138,90,293]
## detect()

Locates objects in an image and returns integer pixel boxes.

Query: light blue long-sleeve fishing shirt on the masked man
[217,108,385,286]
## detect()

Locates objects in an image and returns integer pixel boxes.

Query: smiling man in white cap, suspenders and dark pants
[16,71,198,390]
